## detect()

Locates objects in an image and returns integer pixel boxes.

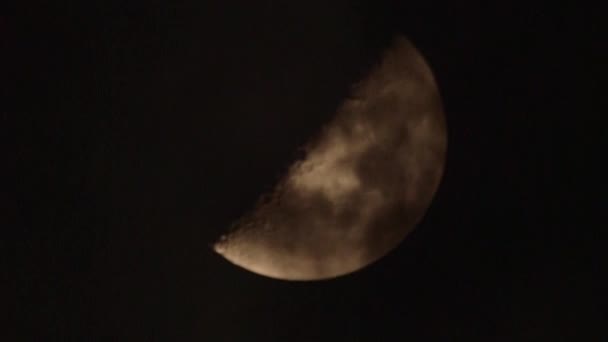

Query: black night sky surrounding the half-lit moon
[0,0,608,341]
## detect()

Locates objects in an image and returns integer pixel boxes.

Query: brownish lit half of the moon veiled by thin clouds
[213,37,447,280]
